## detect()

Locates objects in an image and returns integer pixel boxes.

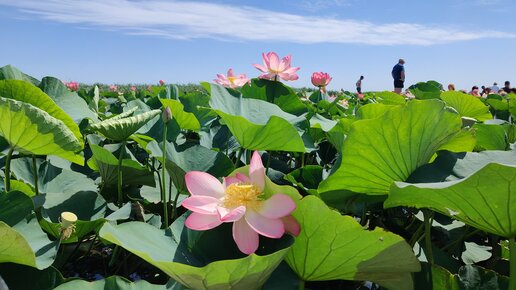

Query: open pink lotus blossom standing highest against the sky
[253,52,299,81]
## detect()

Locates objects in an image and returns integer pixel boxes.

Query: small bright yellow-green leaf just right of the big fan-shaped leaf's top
[441,92,493,121]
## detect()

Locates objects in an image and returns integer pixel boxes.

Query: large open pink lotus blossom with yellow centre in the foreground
[182,151,300,255]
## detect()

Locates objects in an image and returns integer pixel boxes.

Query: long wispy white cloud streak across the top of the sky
[0,0,515,45]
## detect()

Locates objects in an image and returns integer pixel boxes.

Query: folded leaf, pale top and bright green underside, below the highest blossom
[210,84,308,152]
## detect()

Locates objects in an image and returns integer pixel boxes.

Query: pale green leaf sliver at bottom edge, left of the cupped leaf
[55,276,171,290]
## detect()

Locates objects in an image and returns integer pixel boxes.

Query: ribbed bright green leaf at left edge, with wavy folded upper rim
[0,97,84,165]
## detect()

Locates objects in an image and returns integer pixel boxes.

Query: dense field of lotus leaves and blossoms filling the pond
[0,66,516,290]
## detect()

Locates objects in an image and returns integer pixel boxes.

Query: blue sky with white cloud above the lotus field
[0,0,516,91]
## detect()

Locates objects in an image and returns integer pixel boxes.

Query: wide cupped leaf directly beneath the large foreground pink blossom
[99,215,293,290]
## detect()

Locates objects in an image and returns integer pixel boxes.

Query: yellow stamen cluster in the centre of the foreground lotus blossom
[224,183,262,210]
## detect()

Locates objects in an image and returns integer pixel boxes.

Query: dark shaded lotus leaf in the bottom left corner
[0,263,64,290]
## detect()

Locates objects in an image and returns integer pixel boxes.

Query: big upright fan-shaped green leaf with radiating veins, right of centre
[318,100,462,195]
